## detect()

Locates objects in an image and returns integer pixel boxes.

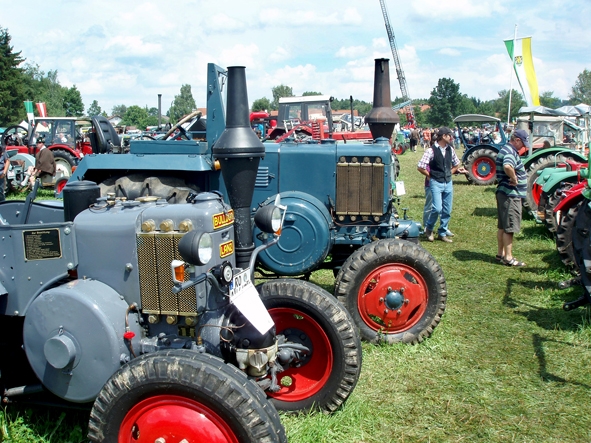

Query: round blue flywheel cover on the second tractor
[254,191,334,276]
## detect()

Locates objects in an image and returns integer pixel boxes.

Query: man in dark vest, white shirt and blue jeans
[417,127,466,243]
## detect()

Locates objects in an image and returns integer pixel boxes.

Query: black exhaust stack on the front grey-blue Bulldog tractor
[213,66,265,269]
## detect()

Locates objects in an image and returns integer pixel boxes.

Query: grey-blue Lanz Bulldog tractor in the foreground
[0,67,361,443]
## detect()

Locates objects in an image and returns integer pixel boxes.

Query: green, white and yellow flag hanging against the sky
[505,37,540,106]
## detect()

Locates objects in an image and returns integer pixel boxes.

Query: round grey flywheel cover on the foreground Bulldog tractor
[23,279,140,403]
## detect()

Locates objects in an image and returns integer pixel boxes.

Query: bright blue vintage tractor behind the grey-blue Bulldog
[57,59,446,343]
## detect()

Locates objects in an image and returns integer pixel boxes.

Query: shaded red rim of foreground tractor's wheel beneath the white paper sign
[267,308,333,402]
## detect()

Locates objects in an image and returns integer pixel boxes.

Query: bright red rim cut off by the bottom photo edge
[118,395,238,443]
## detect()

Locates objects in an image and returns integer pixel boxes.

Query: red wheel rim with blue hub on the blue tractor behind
[357,263,429,334]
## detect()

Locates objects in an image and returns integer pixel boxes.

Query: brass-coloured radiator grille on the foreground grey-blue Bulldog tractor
[136,232,197,315]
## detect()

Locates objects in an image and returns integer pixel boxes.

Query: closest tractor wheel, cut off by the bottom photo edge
[88,350,287,443]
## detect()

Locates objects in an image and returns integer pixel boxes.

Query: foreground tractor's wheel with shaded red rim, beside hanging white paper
[257,279,361,412]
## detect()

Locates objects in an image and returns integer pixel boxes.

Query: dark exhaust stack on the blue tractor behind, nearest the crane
[365,58,400,140]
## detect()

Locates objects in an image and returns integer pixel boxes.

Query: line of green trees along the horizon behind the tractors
[0,27,591,128]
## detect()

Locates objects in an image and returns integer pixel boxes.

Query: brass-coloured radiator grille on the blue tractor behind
[336,157,384,216]
